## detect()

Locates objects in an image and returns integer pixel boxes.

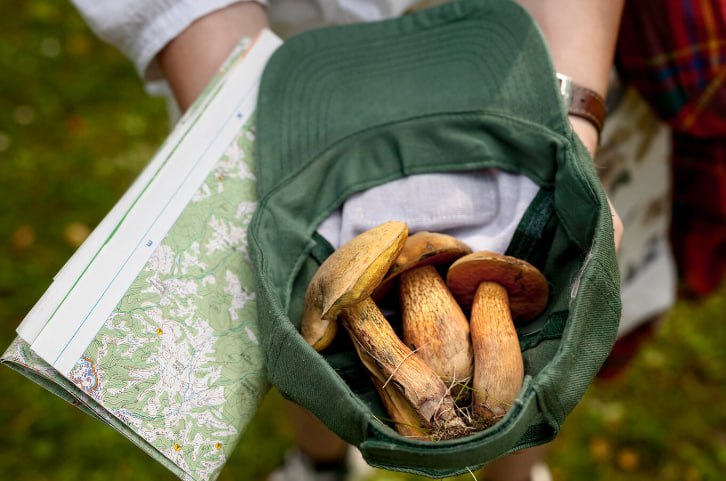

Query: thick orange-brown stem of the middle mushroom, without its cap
[400,265,473,395]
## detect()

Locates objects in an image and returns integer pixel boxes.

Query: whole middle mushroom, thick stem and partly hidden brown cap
[384,231,474,395]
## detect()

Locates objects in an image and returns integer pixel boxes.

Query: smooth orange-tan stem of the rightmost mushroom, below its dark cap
[471,281,524,420]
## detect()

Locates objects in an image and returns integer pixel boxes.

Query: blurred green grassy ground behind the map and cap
[0,0,726,481]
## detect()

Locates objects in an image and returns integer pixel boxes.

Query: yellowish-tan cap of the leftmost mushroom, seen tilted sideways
[300,221,408,351]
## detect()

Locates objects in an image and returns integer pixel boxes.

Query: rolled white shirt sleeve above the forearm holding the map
[71,0,267,83]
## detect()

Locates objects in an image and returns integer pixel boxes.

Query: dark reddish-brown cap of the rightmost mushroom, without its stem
[446,251,549,321]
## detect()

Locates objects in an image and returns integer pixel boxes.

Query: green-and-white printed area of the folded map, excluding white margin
[3,115,268,481]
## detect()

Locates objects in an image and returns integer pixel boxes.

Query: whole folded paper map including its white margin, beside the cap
[1,31,282,481]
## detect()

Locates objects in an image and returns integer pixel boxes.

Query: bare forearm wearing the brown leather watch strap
[516,0,624,152]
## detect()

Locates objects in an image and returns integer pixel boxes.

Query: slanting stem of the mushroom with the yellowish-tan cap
[341,298,463,430]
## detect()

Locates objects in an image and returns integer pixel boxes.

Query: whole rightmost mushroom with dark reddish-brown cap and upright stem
[446,251,549,422]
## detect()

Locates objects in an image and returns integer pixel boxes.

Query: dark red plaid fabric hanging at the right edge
[616,0,726,296]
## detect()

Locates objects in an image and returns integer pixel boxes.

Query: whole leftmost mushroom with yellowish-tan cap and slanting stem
[301,222,463,432]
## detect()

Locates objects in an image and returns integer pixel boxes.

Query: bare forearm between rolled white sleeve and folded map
[157,2,268,111]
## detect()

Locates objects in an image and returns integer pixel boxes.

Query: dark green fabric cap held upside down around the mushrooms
[249,0,620,477]
